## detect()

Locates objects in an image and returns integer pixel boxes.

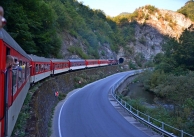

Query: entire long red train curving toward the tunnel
[0,29,118,137]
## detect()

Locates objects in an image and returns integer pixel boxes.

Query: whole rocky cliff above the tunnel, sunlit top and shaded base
[126,5,193,60]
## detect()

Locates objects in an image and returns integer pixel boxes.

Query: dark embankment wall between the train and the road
[25,66,118,137]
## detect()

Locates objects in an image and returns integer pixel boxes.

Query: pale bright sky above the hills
[77,0,189,17]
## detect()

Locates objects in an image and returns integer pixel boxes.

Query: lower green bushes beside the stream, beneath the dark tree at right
[138,55,194,134]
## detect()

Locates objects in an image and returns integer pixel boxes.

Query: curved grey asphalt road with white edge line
[54,71,148,137]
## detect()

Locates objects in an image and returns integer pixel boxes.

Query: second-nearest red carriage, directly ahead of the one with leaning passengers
[29,55,52,83]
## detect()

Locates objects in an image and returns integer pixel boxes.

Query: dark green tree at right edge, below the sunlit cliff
[154,26,194,75]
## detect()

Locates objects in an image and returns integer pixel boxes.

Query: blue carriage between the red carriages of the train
[69,59,86,70]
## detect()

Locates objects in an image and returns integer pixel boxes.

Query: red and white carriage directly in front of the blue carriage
[51,59,70,75]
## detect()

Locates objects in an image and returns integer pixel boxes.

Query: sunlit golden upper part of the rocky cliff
[142,8,192,38]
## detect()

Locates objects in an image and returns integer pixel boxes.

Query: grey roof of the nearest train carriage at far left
[0,28,30,59]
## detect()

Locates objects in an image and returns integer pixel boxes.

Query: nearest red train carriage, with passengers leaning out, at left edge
[0,29,30,136]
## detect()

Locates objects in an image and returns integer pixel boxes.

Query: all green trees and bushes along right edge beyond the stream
[137,26,194,135]
